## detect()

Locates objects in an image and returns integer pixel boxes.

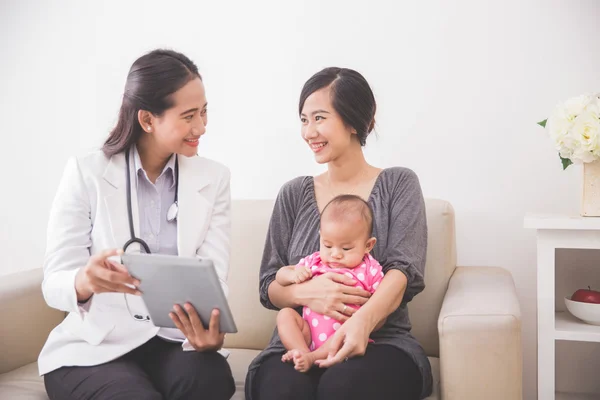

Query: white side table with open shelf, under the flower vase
[525,215,600,400]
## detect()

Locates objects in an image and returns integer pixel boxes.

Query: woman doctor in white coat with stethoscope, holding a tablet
[38,50,235,400]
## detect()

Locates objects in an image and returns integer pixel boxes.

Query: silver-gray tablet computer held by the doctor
[121,253,237,333]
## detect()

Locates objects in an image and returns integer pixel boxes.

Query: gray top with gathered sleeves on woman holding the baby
[246,167,432,400]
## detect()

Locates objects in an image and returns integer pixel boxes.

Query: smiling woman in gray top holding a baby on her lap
[246,68,432,400]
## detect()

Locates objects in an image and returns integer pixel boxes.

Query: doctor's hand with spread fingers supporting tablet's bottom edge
[169,303,225,351]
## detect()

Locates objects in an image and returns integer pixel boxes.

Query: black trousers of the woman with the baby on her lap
[252,344,423,400]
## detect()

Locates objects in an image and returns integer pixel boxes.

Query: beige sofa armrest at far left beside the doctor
[0,269,65,374]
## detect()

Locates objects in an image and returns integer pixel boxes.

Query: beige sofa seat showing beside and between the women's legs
[0,356,440,400]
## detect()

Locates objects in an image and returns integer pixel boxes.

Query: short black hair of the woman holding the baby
[298,67,377,146]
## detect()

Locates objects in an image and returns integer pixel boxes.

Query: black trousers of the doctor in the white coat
[44,337,235,400]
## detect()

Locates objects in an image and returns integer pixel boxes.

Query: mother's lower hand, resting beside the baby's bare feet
[315,315,371,368]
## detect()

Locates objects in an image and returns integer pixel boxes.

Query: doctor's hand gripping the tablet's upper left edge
[75,249,140,302]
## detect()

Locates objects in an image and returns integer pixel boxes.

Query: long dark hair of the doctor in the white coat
[102,49,202,157]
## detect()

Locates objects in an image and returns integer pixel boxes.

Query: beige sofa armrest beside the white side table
[438,267,523,400]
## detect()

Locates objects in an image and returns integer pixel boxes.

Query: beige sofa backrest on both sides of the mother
[225,199,456,357]
